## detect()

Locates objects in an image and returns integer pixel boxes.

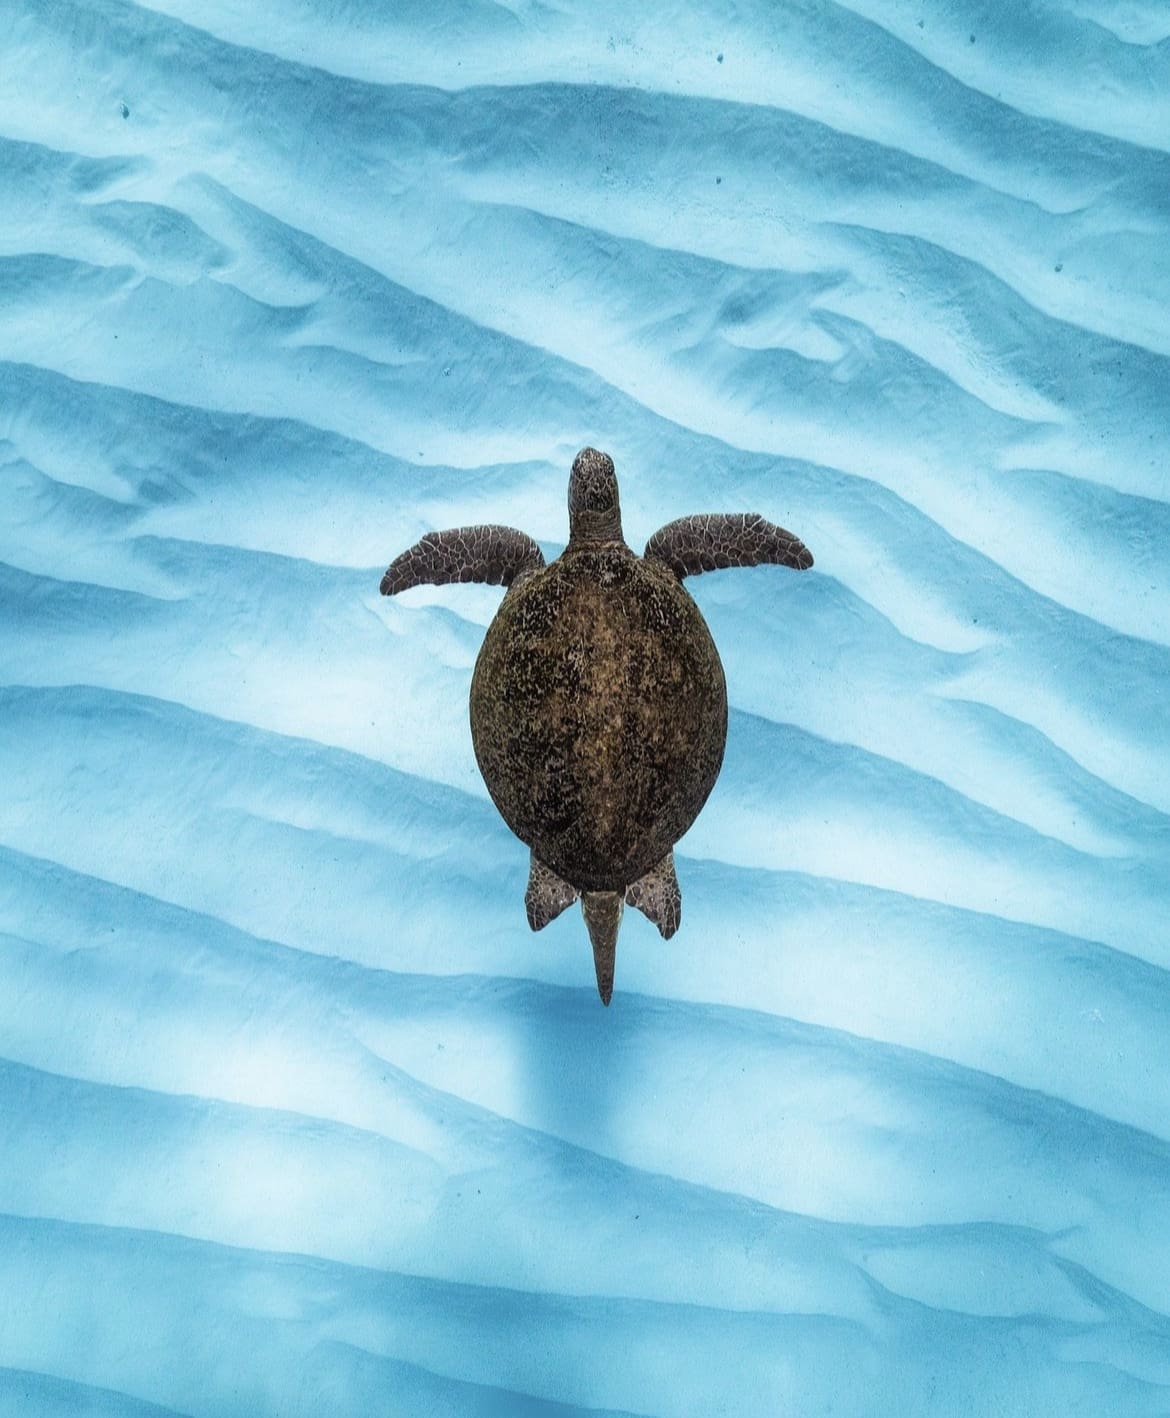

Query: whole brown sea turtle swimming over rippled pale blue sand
[381,448,813,1004]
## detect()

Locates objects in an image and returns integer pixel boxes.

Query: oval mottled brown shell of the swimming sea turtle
[471,546,728,891]
